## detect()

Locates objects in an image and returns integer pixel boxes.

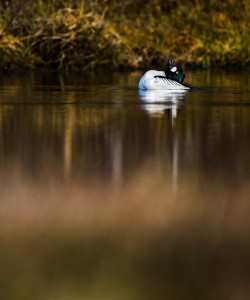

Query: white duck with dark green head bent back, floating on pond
[139,58,192,90]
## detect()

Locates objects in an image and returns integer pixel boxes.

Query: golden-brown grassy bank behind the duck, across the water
[0,0,250,69]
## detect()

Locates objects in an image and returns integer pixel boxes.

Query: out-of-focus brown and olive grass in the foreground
[0,170,250,300]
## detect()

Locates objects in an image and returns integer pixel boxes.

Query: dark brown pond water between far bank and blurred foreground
[0,72,250,188]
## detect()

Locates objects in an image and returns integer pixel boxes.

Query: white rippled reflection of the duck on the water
[139,90,187,119]
